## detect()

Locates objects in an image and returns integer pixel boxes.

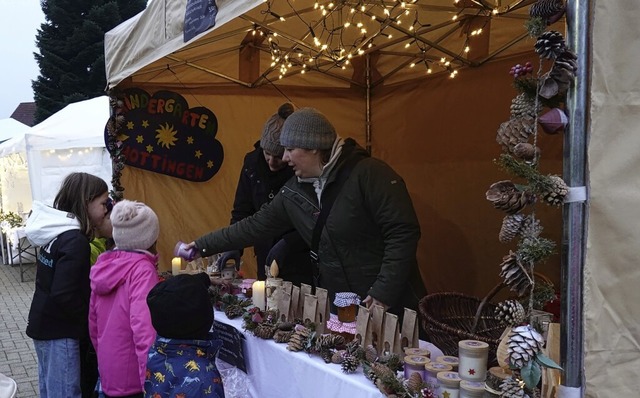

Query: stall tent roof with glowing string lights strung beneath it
[105,0,534,88]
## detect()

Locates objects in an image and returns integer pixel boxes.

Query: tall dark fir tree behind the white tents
[32,0,147,123]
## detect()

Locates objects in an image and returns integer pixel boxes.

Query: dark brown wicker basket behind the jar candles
[418,292,505,366]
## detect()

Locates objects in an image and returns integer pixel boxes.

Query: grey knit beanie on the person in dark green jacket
[280,108,337,149]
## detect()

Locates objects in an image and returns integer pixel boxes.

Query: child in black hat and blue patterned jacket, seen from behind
[144,273,224,398]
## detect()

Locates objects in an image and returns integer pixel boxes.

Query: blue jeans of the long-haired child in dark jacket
[33,339,82,398]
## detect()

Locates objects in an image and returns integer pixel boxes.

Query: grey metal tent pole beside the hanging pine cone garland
[558,0,591,397]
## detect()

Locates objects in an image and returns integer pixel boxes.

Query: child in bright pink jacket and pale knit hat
[89,200,159,397]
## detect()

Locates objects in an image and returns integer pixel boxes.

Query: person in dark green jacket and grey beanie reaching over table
[184,108,425,315]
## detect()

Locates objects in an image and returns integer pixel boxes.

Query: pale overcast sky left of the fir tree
[0,0,44,119]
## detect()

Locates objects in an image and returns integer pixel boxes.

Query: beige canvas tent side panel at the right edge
[584,1,640,398]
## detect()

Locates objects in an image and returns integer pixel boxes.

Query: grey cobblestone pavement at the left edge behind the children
[0,264,38,398]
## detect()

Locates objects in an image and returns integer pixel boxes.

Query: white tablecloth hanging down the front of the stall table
[215,311,440,398]
